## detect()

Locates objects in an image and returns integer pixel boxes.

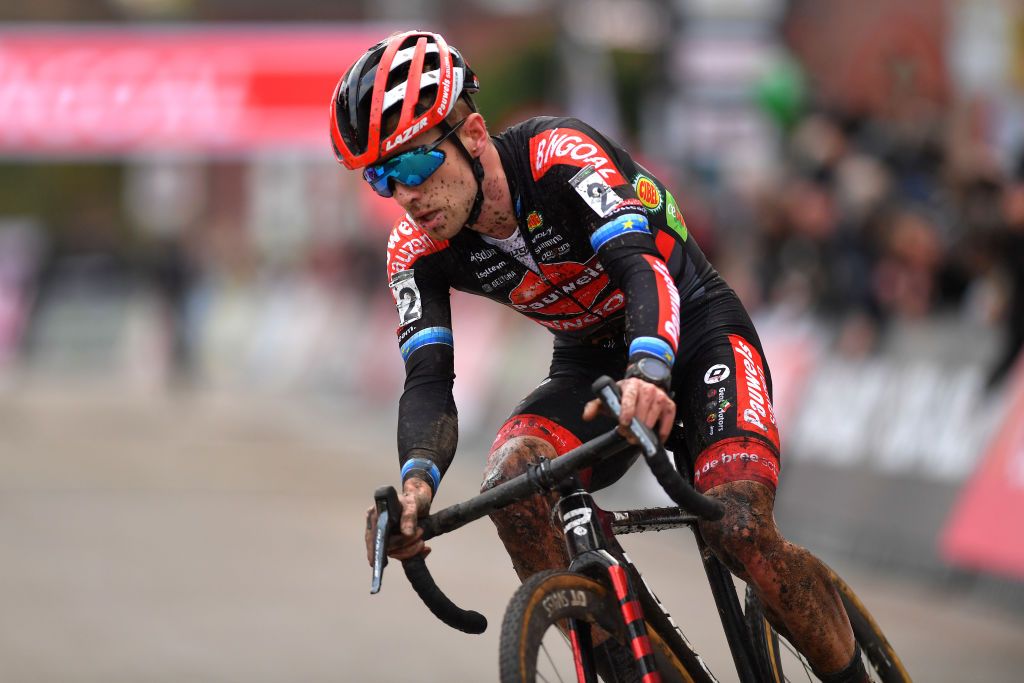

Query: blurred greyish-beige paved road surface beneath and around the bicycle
[0,385,1024,683]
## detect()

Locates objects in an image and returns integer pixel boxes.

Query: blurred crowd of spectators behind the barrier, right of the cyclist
[684,101,1024,384]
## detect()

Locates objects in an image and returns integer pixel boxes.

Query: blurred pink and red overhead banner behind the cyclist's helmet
[0,25,391,156]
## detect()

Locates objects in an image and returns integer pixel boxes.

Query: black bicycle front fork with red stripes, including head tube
[556,489,662,683]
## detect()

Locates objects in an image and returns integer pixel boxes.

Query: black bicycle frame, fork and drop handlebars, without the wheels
[371,377,782,683]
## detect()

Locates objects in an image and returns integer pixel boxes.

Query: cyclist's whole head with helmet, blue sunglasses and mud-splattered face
[331,31,485,239]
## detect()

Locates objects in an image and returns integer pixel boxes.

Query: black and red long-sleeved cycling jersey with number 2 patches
[387,117,728,485]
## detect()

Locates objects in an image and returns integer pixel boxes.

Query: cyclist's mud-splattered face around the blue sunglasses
[385,130,476,240]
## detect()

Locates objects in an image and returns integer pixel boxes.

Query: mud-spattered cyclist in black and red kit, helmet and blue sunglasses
[342,31,865,681]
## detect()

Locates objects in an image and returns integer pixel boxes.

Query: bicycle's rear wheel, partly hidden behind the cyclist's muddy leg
[746,569,910,683]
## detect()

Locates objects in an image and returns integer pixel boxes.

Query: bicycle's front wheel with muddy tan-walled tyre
[500,570,711,683]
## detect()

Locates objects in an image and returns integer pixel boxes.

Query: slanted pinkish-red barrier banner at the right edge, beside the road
[942,360,1024,579]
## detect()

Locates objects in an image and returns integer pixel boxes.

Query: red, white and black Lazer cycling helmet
[331,31,480,169]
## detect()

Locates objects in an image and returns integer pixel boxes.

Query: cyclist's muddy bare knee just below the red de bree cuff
[700,481,785,579]
